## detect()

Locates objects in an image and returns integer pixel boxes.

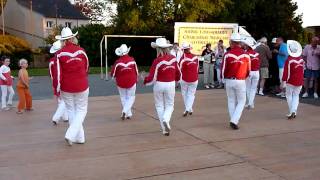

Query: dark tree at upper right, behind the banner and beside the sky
[211,0,303,39]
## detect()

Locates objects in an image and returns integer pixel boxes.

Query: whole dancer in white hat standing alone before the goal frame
[111,44,138,120]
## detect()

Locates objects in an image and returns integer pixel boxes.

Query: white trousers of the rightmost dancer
[286,84,302,113]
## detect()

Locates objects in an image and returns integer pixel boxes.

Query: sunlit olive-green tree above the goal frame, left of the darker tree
[112,0,231,39]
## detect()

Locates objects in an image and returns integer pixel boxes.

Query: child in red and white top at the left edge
[0,57,14,111]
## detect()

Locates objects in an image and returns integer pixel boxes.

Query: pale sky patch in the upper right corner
[293,0,320,27]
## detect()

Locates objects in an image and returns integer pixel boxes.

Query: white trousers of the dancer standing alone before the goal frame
[118,84,137,117]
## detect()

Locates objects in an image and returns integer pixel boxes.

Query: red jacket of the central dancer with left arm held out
[143,54,180,85]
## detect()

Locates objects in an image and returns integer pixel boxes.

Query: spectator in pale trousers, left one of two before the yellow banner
[202,43,215,89]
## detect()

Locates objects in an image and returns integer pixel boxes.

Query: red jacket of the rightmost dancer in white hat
[282,56,305,86]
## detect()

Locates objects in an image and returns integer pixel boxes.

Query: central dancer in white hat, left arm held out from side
[144,38,180,136]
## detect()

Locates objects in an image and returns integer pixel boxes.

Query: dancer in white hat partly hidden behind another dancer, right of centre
[242,36,260,109]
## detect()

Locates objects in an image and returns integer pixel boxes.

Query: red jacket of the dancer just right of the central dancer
[179,53,199,82]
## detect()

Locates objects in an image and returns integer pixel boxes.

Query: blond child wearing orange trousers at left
[17,59,32,114]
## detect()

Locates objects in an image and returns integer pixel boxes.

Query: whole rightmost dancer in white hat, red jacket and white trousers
[282,40,305,119]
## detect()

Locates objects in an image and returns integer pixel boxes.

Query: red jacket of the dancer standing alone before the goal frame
[111,55,138,88]
